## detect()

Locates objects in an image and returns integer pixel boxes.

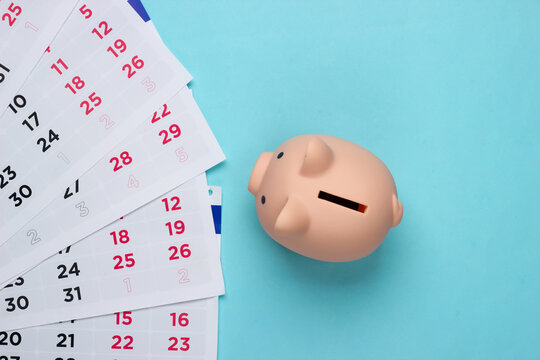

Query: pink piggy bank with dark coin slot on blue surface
[248,135,403,262]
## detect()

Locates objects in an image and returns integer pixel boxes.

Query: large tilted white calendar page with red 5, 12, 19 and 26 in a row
[0,0,191,244]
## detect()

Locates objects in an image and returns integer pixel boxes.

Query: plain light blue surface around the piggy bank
[143,0,540,360]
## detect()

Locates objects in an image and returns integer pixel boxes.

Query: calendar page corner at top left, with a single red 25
[0,0,77,115]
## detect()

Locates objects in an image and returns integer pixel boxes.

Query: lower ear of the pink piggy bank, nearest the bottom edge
[274,195,309,236]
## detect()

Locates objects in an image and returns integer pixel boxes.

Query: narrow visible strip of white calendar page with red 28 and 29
[0,87,224,286]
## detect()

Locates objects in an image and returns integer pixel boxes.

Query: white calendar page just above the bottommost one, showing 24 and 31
[0,175,224,329]
